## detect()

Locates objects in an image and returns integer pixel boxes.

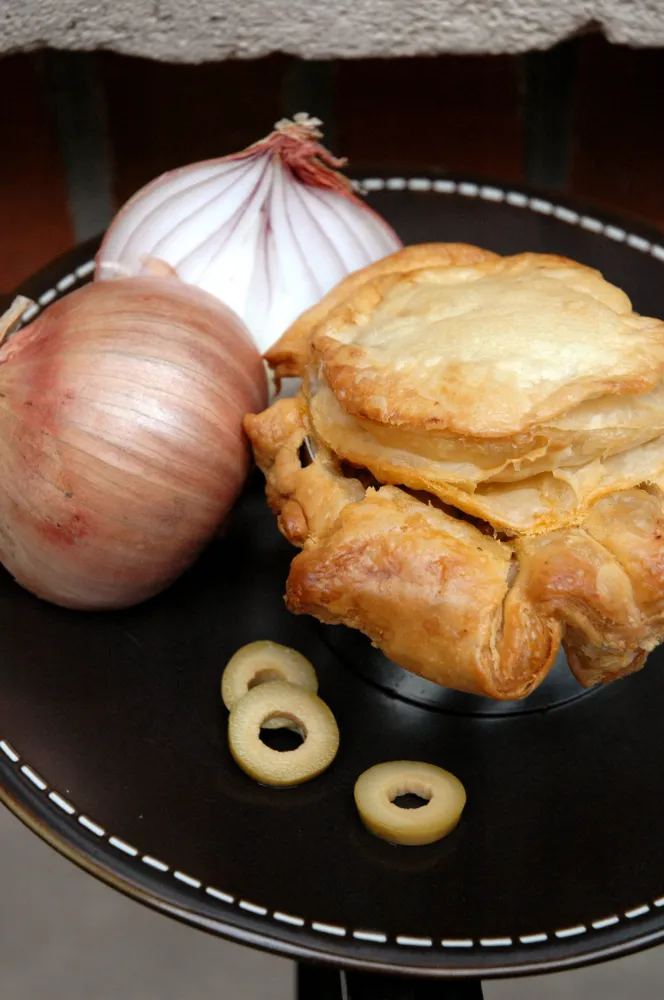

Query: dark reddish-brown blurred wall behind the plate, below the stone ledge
[0,35,664,291]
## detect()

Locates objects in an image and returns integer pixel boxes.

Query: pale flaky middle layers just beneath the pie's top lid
[306,376,664,535]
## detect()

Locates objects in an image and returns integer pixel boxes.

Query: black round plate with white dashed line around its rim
[0,176,664,976]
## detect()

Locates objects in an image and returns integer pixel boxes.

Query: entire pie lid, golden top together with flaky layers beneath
[268,244,664,534]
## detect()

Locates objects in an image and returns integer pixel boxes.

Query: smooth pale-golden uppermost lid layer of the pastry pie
[268,244,664,437]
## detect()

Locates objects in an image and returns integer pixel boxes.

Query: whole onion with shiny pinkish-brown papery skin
[0,277,266,609]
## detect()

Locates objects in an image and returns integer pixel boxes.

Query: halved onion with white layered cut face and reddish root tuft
[97,115,401,351]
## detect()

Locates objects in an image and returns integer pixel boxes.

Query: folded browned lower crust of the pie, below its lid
[246,397,664,699]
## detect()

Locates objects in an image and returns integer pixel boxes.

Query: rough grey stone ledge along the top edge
[0,0,664,62]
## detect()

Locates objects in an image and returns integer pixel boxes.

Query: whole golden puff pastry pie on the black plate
[245,244,664,699]
